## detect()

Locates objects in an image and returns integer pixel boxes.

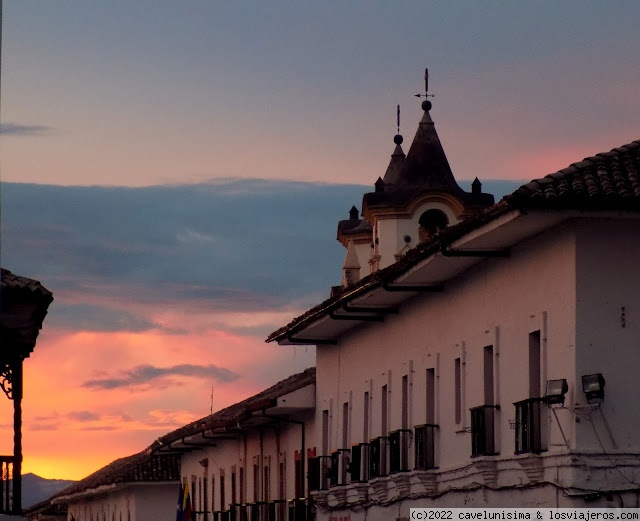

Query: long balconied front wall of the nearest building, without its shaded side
[316,218,592,519]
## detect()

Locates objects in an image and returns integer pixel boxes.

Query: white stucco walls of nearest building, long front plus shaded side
[316,216,640,521]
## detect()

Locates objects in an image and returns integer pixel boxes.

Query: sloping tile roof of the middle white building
[153,367,316,451]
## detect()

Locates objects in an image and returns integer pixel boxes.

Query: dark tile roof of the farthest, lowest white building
[50,450,180,501]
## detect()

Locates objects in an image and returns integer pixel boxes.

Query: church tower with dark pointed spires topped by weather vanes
[338,71,494,286]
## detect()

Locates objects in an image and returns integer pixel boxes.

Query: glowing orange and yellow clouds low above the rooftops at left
[0,324,314,479]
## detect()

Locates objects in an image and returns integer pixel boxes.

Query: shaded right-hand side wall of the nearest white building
[576,219,640,453]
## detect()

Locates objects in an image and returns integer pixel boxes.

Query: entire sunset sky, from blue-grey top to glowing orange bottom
[0,0,640,479]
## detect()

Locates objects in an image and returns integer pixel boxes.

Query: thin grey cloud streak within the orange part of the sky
[82,364,238,389]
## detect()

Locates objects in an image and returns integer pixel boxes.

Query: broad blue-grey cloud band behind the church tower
[0,179,517,331]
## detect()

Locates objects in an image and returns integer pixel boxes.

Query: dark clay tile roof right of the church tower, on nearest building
[505,140,640,210]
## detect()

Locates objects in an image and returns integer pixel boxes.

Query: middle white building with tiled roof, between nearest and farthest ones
[153,368,318,521]
